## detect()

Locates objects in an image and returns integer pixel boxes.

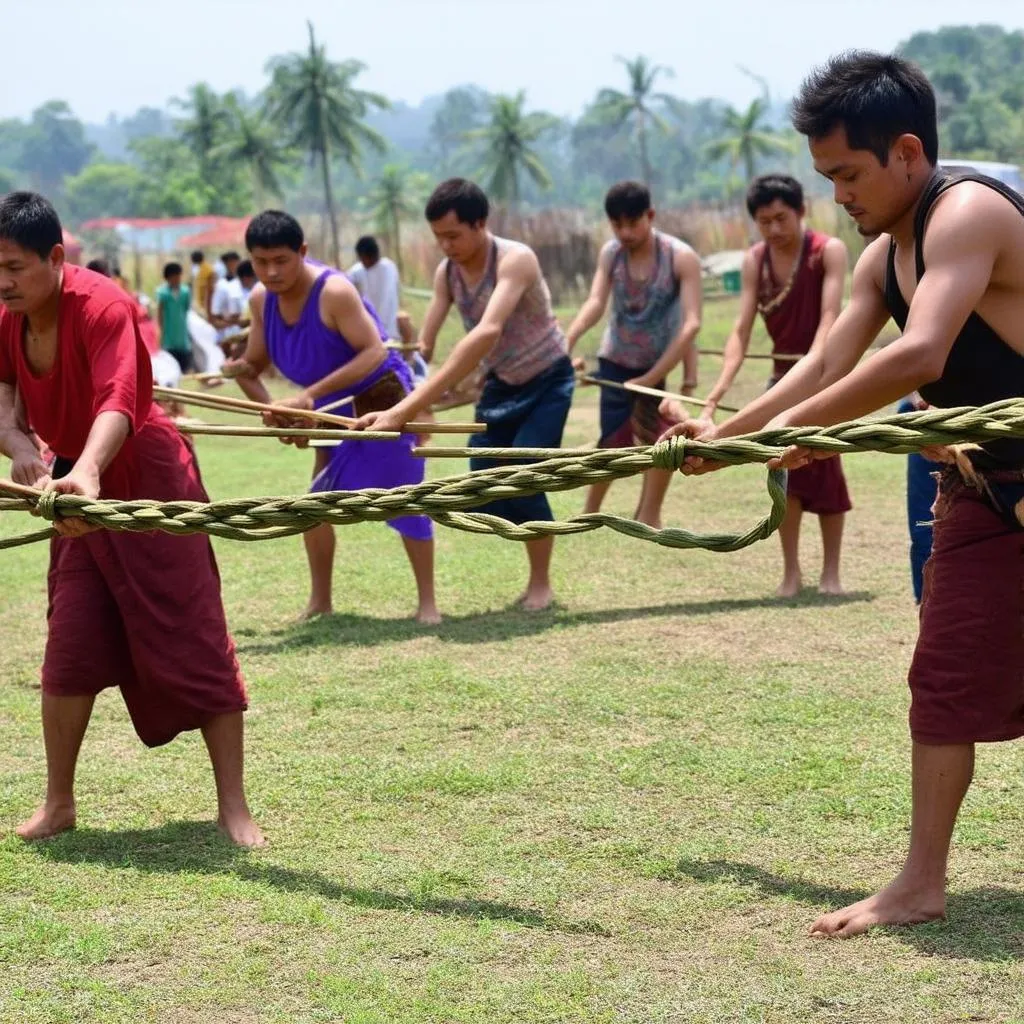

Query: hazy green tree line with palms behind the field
[0,25,1024,266]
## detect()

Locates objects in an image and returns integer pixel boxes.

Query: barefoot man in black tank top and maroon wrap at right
[673,51,1024,937]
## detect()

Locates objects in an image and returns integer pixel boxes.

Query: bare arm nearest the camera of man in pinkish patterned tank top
[370,250,541,429]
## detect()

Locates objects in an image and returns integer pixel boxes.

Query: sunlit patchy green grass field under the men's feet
[0,304,1024,1024]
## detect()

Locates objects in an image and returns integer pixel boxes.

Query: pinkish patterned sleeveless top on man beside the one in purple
[444,237,568,385]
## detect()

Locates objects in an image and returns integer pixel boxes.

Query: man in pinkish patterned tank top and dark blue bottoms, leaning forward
[357,178,574,611]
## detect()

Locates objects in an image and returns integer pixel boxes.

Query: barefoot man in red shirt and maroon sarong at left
[0,193,263,846]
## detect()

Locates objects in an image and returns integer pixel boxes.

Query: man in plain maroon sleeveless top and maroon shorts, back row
[705,174,853,597]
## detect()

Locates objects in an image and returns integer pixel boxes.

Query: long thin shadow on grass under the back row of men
[236,591,874,655]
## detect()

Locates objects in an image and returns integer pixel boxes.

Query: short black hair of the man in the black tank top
[793,50,939,167]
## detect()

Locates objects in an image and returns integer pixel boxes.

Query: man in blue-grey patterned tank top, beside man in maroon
[566,181,703,527]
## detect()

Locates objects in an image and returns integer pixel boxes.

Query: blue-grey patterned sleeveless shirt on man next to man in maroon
[598,231,690,371]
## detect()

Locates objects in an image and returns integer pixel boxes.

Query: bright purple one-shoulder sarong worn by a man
[263,267,433,541]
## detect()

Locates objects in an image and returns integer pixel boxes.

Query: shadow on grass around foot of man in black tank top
[660,858,1024,962]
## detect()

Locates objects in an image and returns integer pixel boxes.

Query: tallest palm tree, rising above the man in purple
[267,22,389,266]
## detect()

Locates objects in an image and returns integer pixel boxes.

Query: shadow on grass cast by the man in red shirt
[33,821,611,937]
